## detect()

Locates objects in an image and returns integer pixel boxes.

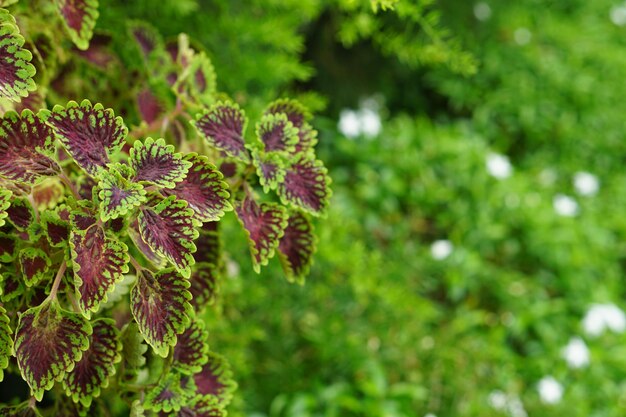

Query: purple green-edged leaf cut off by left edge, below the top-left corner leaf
[0,109,61,185]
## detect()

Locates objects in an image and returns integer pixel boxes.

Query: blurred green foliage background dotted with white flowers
[98,0,626,417]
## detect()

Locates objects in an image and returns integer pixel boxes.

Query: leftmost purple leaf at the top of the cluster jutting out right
[192,101,250,162]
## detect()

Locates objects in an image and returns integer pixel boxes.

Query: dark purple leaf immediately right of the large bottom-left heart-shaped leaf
[63,318,122,407]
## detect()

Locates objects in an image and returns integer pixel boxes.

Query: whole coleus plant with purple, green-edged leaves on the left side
[0,0,330,416]
